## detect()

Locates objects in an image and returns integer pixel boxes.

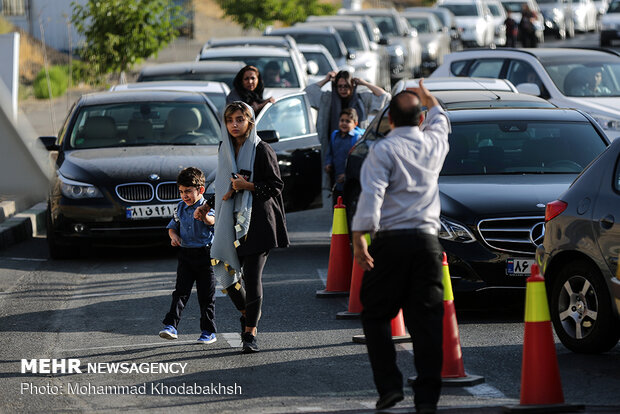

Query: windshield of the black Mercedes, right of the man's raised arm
[441,120,606,175]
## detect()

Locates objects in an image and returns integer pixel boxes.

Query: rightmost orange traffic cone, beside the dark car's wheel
[520,264,564,405]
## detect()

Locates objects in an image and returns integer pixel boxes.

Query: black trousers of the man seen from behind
[360,234,443,406]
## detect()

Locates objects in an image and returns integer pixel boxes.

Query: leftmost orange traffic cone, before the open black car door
[316,197,353,298]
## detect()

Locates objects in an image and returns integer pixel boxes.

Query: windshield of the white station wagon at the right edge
[541,56,620,97]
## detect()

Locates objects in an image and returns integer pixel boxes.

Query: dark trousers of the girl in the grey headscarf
[226,251,269,328]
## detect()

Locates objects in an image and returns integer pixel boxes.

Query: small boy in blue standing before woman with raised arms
[325,108,364,200]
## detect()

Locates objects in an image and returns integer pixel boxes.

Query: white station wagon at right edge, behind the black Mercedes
[430,48,620,140]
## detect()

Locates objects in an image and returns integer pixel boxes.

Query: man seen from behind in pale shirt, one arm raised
[352,80,450,414]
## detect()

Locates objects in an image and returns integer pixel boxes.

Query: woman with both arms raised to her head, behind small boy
[306,70,391,192]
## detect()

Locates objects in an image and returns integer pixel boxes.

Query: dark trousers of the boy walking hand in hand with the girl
[163,247,217,333]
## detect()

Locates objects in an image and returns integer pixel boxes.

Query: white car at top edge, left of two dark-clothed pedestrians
[437,0,495,47]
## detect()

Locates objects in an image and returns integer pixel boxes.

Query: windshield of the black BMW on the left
[64,102,221,149]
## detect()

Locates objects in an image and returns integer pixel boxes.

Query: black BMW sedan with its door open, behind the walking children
[40,90,321,258]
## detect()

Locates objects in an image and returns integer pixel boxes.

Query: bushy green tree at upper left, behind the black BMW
[71,0,184,75]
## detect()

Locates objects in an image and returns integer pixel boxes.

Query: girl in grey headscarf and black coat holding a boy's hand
[195,102,289,353]
